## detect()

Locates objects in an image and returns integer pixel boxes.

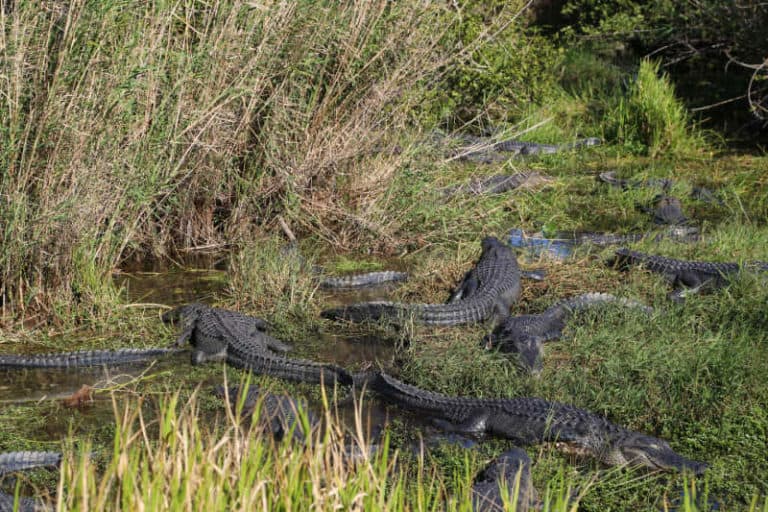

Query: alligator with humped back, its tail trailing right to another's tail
[163,302,352,385]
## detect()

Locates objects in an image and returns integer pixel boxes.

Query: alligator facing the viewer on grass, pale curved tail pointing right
[483,293,653,375]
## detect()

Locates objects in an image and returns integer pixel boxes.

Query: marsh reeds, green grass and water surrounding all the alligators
[0,0,768,511]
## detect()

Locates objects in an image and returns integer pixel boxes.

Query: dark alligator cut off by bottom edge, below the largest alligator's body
[472,448,537,512]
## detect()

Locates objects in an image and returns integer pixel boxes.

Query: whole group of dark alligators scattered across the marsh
[0,135,768,512]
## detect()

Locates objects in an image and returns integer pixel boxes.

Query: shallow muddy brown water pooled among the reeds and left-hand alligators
[0,260,432,451]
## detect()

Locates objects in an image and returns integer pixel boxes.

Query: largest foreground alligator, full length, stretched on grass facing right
[354,371,707,475]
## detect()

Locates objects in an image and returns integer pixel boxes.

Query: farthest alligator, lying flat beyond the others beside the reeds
[456,137,602,163]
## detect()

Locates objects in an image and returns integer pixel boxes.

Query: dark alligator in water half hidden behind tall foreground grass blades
[214,385,320,442]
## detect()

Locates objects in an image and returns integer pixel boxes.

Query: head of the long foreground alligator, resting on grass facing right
[602,432,707,475]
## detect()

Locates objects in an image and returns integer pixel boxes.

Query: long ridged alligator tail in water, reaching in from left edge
[0,348,181,370]
